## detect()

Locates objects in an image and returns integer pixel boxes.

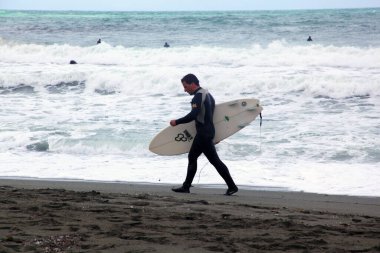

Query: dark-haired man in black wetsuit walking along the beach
[170,74,238,195]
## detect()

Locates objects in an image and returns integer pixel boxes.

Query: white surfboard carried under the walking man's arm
[149,99,263,155]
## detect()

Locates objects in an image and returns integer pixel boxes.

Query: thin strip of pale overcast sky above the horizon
[0,0,380,11]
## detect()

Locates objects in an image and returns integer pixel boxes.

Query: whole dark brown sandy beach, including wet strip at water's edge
[0,179,380,252]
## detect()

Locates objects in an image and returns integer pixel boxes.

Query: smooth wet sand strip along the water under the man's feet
[0,178,380,217]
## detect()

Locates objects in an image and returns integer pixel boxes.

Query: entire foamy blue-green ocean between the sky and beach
[0,6,380,196]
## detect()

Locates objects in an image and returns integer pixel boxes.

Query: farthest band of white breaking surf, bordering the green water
[0,40,380,68]
